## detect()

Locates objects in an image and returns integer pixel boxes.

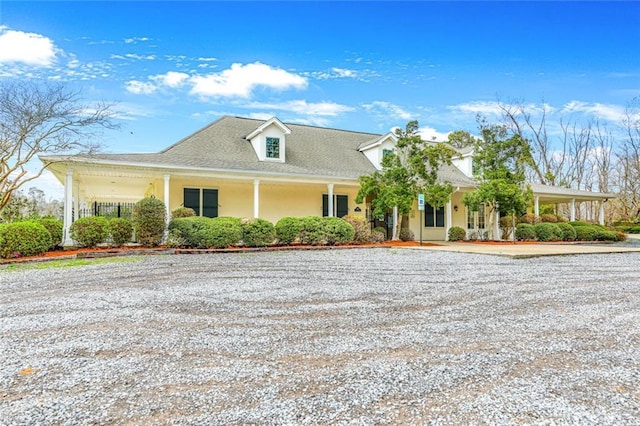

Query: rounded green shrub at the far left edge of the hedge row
[0,221,51,259]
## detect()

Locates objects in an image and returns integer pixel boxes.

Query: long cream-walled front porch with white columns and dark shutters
[45,163,365,250]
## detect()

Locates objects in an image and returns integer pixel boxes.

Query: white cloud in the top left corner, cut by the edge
[0,26,58,67]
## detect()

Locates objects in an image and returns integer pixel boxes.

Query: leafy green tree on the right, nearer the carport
[462,120,532,238]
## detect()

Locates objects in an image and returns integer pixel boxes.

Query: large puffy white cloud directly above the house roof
[191,62,308,98]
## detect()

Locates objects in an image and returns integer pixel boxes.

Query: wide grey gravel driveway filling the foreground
[0,249,640,425]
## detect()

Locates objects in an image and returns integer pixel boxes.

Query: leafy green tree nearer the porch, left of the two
[356,121,455,240]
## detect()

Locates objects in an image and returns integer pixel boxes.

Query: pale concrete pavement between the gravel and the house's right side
[402,237,640,259]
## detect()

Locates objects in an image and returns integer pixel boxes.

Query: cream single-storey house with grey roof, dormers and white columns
[41,116,613,245]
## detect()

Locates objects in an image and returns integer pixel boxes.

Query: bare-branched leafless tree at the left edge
[0,81,116,216]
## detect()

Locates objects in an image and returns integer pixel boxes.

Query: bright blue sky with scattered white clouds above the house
[0,0,640,196]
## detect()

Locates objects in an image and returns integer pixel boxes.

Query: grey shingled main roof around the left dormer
[92,116,380,178]
